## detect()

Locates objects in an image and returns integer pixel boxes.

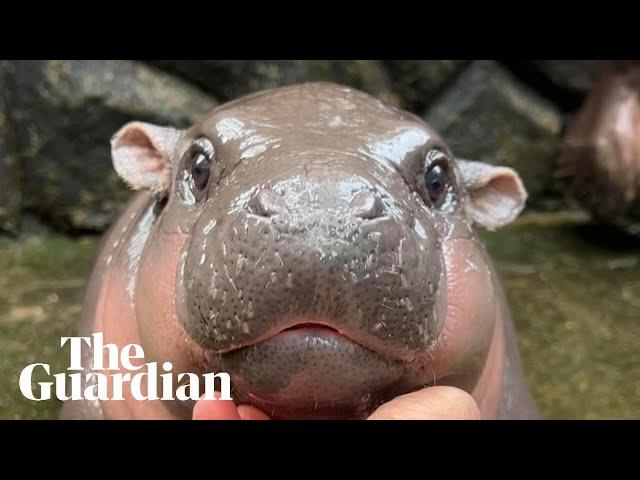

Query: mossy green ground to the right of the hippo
[483,212,640,419]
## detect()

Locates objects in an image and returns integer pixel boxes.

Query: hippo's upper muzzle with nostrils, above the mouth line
[178,171,441,359]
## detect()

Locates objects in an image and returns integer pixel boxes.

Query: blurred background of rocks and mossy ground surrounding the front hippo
[0,60,640,419]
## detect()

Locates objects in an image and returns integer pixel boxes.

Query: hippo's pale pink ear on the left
[111,122,180,194]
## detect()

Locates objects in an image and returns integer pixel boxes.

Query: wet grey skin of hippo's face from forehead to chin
[172,86,455,412]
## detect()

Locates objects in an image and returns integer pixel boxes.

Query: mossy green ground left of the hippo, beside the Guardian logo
[0,236,95,419]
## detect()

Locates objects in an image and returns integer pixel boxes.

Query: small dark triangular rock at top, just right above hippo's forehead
[384,60,468,113]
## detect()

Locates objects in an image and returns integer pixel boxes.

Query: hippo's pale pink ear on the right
[458,160,527,230]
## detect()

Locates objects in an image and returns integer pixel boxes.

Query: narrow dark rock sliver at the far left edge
[0,94,21,233]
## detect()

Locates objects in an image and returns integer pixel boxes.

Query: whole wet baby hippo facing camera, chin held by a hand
[62,83,537,418]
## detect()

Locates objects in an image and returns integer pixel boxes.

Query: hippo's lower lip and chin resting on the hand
[220,321,405,418]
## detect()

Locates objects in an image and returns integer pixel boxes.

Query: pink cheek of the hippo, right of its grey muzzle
[431,238,497,391]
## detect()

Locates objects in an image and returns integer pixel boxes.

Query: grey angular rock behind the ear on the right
[425,61,562,206]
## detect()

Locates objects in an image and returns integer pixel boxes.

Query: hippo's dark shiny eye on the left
[181,138,214,204]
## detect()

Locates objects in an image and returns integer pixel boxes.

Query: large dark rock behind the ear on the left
[1,60,216,231]
